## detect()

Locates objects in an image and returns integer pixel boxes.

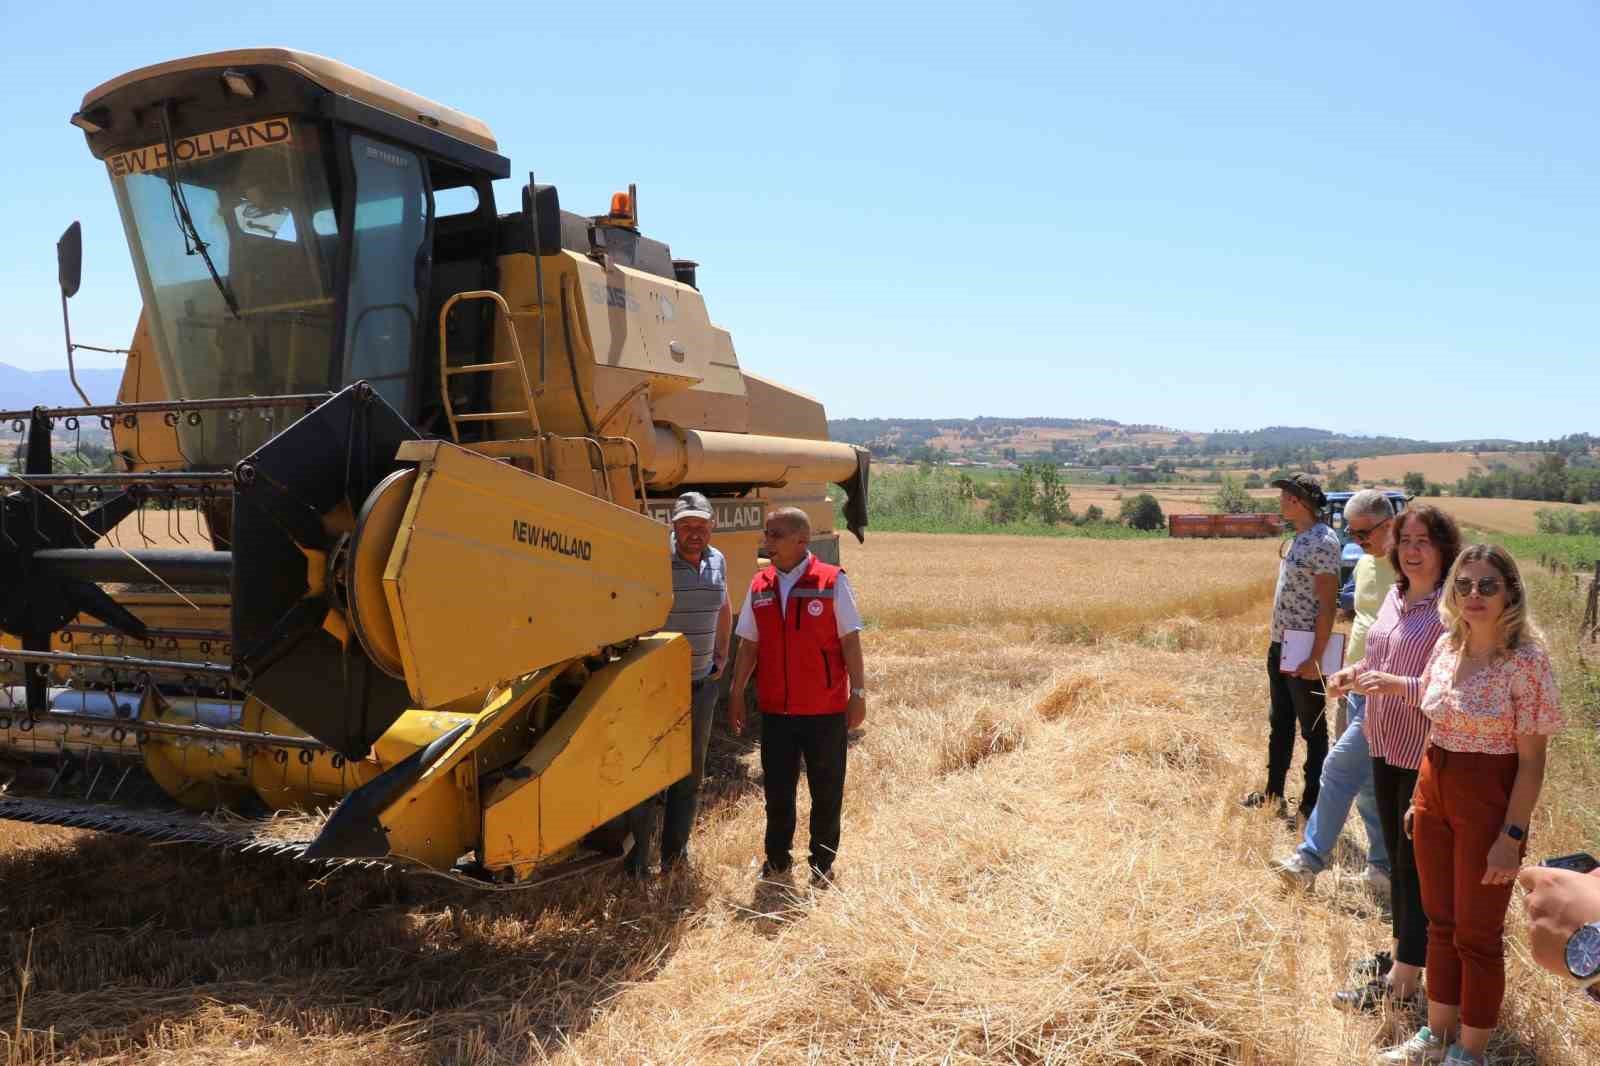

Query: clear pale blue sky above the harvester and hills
[0,0,1600,439]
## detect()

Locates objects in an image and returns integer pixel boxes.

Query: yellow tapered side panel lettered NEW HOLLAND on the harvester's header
[384,442,672,707]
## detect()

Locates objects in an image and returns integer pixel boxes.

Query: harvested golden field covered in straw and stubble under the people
[0,535,1600,1066]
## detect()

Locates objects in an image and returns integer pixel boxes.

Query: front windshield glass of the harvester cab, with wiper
[109,118,344,466]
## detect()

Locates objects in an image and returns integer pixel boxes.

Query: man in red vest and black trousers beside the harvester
[728,507,867,887]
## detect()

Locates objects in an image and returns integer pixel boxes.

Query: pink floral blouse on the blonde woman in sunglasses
[1422,640,1565,755]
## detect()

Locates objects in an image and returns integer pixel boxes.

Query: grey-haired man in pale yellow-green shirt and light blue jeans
[1274,488,1395,896]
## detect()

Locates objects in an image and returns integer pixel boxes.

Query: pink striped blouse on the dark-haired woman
[1360,586,1445,770]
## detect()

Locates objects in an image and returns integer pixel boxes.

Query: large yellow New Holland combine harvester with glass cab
[0,48,867,884]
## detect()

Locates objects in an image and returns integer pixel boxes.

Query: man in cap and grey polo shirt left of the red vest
[624,493,733,877]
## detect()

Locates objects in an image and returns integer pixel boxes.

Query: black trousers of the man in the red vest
[762,711,848,872]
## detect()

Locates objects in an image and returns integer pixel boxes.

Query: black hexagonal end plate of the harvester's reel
[232,383,418,759]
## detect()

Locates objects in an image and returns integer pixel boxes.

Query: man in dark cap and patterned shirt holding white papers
[1243,474,1339,818]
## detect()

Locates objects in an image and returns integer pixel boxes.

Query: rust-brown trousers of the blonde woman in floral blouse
[1411,746,1526,1029]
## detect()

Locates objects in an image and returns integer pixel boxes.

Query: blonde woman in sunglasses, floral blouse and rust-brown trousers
[1406,544,1562,1063]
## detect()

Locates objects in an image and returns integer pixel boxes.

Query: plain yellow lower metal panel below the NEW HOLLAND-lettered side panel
[480,634,691,872]
